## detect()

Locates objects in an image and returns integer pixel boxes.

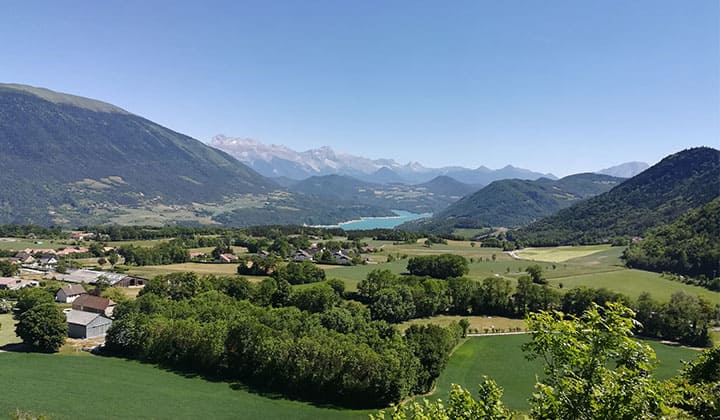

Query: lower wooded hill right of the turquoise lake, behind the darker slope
[408,173,622,232]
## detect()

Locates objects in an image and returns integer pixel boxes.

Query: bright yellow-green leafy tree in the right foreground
[523,303,665,420]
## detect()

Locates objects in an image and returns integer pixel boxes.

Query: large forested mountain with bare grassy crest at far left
[0,84,275,224]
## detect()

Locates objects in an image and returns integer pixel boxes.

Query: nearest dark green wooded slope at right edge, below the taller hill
[624,197,720,282]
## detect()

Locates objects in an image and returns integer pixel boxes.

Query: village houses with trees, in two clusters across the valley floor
[0,232,378,344]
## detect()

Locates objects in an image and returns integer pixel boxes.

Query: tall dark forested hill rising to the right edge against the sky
[509,147,720,246]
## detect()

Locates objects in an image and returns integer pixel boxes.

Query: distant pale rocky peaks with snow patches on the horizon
[210,135,556,186]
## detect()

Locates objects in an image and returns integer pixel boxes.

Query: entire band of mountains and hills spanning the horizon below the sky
[0,84,696,235]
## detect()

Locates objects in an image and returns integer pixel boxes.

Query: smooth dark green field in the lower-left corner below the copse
[0,353,369,420]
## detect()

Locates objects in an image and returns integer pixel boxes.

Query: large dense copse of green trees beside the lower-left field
[107,273,461,407]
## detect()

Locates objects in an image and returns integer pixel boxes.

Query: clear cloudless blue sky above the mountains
[0,0,720,175]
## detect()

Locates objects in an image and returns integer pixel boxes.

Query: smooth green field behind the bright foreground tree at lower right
[429,335,699,411]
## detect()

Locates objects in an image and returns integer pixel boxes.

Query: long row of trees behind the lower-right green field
[357,266,720,346]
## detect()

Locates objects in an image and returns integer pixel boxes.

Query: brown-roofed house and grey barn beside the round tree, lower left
[55,284,115,338]
